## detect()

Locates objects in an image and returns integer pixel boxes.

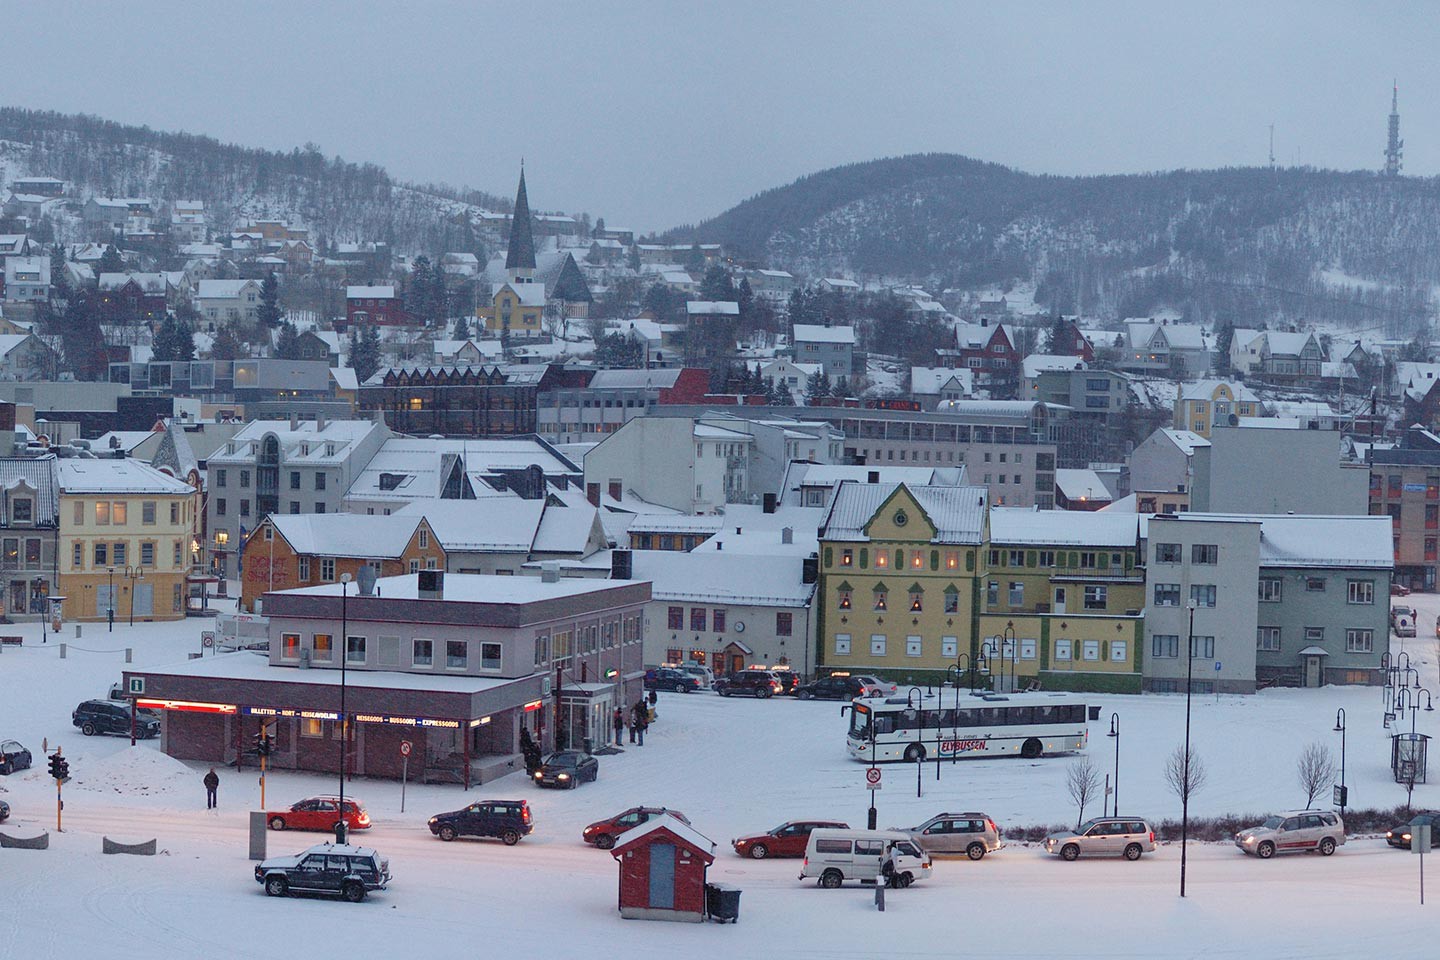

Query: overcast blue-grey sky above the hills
[0,0,1440,230]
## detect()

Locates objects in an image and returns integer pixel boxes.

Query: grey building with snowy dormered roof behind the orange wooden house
[204,419,390,577]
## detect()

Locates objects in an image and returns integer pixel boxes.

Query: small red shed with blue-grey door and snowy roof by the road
[611,816,716,923]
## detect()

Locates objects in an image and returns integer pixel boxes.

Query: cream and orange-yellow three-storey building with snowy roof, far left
[59,459,199,620]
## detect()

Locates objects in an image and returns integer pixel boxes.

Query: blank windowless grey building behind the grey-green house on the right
[1186,425,1369,515]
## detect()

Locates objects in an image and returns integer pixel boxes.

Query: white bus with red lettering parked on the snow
[845,689,1100,763]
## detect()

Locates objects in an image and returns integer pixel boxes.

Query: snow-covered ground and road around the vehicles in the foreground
[0,613,1440,959]
